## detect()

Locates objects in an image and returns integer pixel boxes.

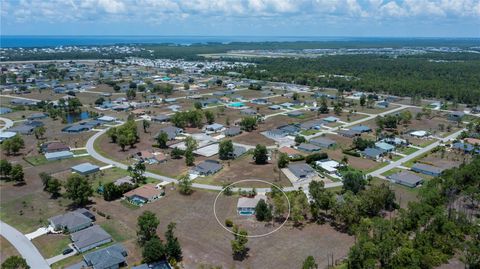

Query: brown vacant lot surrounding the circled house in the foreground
[86,189,354,268]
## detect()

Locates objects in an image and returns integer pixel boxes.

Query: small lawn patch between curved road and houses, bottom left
[32,234,72,259]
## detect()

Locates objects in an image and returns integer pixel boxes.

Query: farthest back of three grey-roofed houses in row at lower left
[48,210,92,233]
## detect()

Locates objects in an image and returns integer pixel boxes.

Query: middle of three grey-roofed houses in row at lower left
[70,225,112,252]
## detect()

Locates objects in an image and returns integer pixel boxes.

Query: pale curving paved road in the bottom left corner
[0,221,50,269]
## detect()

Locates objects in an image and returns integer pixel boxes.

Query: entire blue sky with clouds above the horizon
[0,0,480,37]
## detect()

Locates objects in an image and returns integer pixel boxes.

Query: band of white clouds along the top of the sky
[0,0,480,23]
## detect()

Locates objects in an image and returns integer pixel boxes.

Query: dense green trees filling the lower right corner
[346,157,480,269]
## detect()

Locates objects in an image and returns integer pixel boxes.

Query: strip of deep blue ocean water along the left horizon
[0,35,351,48]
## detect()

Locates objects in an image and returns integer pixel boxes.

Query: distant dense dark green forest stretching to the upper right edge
[216,53,480,104]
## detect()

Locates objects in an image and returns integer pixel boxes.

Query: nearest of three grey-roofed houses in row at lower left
[83,244,127,269]
